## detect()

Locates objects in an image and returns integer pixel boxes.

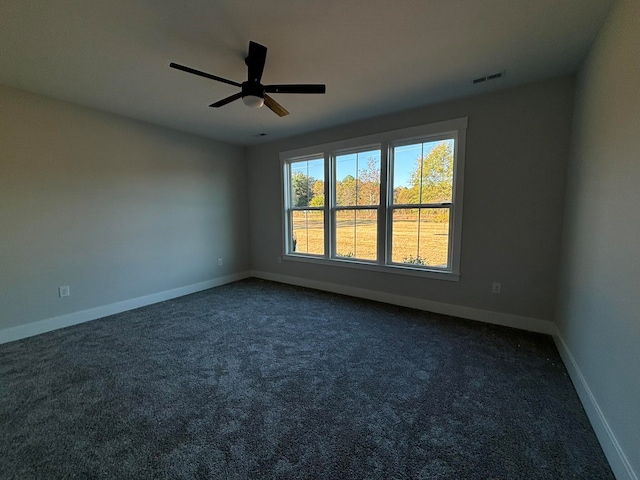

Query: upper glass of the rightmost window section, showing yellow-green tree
[393,138,455,205]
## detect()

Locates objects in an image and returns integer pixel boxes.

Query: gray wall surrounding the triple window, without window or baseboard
[247,77,574,320]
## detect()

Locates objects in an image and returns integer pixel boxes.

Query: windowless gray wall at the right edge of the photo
[558,0,640,478]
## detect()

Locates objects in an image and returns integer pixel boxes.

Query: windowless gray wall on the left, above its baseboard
[0,87,249,330]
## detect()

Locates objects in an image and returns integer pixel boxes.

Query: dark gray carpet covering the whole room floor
[0,280,613,480]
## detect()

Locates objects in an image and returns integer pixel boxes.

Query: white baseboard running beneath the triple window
[251,270,556,335]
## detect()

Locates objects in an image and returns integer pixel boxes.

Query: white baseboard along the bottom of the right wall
[554,332,638,480]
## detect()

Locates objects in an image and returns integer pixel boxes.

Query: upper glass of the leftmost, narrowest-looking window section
[289,158,324,207]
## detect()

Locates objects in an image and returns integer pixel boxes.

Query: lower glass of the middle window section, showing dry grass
[336,209,378,260]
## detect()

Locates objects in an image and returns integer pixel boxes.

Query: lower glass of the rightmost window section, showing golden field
[391,208,449,268]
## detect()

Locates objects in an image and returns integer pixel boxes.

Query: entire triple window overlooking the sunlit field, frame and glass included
[281,118,467,280]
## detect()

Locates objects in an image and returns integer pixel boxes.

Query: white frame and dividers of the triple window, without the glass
[280,117,468,281]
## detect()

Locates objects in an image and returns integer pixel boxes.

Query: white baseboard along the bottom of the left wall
[0,272,249,344]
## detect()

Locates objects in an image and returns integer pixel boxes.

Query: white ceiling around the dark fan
[0,0,612,145]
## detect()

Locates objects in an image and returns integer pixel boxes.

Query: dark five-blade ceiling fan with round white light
[169,42,326,117]
